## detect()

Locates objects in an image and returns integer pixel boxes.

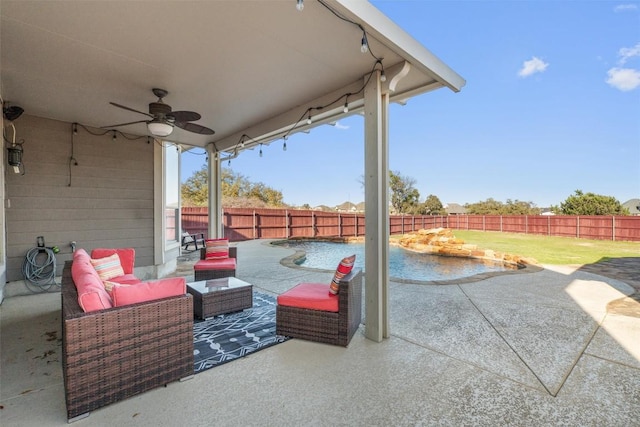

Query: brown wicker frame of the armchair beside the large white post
[276,268,362,347]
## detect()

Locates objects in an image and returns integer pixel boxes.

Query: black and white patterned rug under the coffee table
[193,291,289,374]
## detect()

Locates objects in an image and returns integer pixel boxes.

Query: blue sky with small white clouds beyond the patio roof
[182,0,640,207]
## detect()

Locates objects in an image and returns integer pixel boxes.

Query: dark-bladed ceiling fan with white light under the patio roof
[102,88,214,136]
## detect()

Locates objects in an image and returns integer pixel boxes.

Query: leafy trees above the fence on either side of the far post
[182,165,284,207]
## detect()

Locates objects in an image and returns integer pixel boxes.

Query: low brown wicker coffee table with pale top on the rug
[187,277,253,319]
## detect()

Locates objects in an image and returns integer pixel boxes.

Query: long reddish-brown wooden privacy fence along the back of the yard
[182,208,640,241]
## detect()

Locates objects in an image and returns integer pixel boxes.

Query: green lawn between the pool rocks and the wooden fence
[444,230,640,264]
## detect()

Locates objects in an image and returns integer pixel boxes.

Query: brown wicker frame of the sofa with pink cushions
[61,252,193,422]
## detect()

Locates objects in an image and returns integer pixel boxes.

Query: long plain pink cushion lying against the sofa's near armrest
[111,277,187,307]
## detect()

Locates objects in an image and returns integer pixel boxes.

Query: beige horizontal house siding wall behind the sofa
[5,115,154,281]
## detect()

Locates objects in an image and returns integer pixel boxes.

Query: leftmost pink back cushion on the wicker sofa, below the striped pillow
[71,249,113,312]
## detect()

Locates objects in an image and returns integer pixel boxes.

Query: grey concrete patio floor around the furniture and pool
[0,241,640,427]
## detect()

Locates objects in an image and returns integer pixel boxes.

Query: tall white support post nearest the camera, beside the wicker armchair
[364,71,389,342]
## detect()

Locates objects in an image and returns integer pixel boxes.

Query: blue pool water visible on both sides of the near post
[281,241,513,281]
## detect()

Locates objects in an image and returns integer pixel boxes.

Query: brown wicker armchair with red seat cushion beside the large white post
[276,268,362,347]
